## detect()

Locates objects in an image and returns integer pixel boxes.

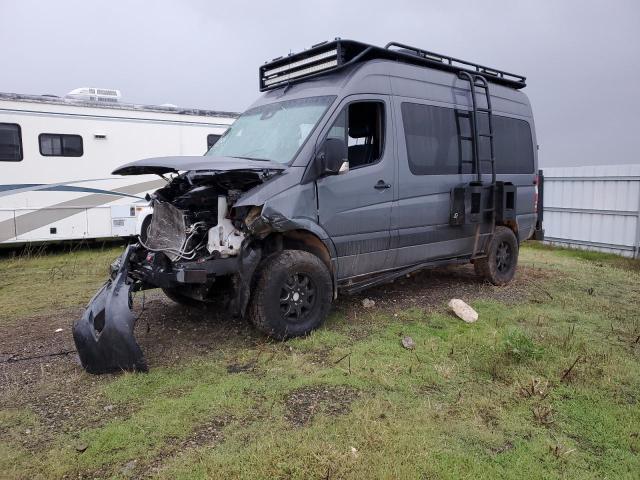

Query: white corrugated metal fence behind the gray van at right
[544,165,640,258]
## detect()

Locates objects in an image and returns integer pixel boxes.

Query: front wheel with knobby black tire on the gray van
[247,250,333,340]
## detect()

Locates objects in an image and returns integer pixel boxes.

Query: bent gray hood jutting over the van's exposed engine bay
[113,155,287,175]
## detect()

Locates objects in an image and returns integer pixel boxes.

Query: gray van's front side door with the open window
[316,95,396,279]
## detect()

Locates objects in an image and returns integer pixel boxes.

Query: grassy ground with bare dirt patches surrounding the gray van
[0,245,640,479]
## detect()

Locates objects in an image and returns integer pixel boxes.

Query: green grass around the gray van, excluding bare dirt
[0,247,640,479]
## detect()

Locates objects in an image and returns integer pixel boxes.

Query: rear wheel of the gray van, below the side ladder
[473,227,519,285]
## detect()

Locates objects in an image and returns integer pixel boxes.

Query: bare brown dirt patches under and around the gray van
[0,266,548,450]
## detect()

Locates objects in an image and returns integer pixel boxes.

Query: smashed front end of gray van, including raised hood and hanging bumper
[73,157,285,373]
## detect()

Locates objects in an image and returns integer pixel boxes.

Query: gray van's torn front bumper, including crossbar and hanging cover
[73,245,262,374]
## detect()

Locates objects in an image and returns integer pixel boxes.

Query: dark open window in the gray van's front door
[347,102,384,169]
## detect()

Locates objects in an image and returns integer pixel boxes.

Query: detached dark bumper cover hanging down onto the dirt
[73,246,147,374]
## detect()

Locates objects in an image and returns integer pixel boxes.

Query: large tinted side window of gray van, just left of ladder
[401,102,473,175]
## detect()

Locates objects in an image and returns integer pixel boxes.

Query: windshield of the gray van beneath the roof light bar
[207,96,335,163]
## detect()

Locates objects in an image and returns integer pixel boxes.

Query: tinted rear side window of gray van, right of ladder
[493,115,533,174]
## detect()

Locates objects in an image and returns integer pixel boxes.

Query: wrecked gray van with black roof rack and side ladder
[74,39,542,373]
